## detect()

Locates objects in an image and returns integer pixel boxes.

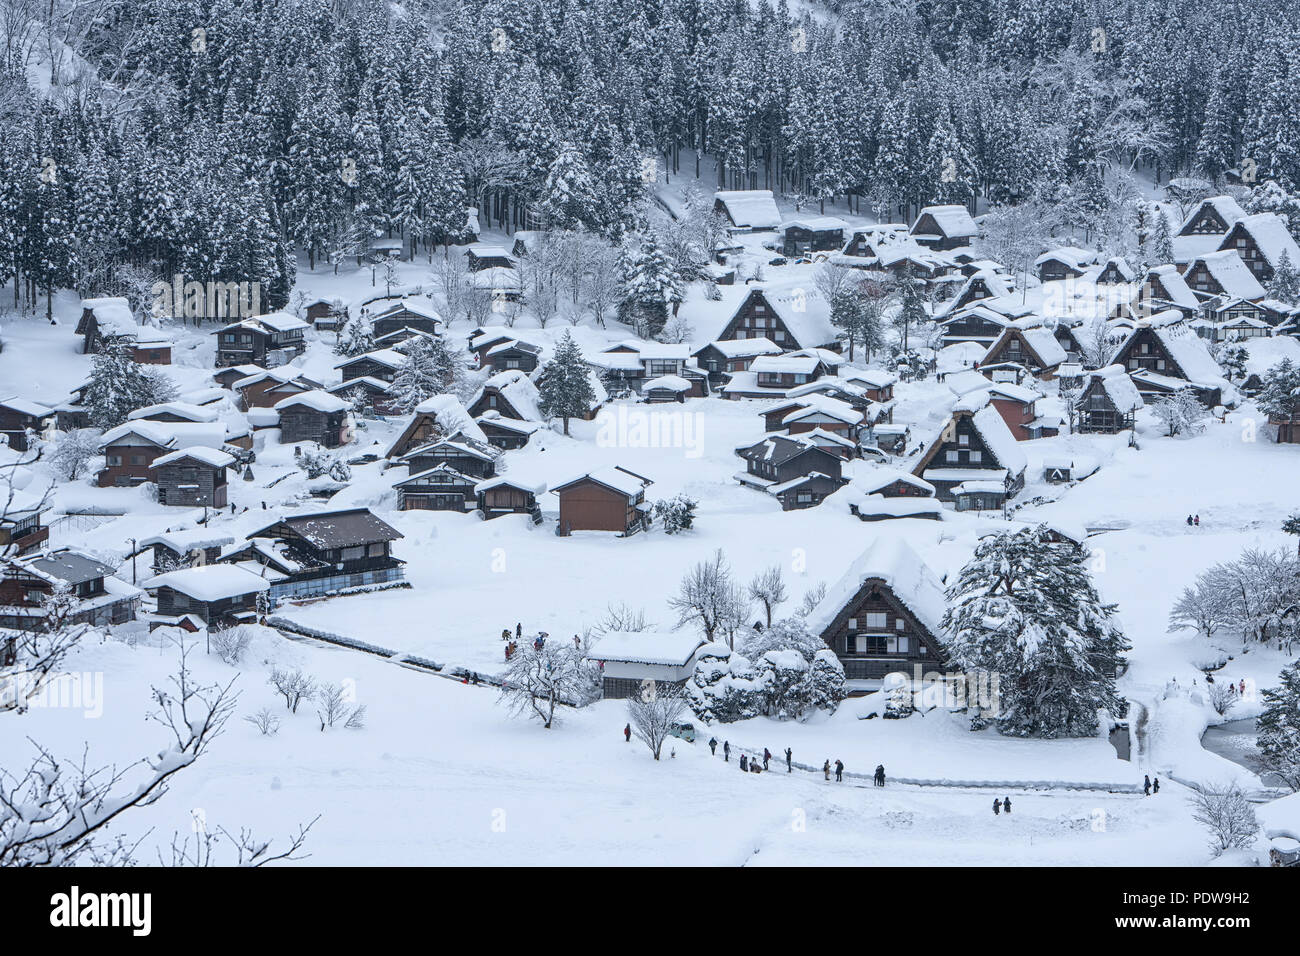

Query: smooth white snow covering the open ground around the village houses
[0,164,1300,866]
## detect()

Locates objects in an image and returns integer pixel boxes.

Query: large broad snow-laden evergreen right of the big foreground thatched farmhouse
[944,525,1128,737]
